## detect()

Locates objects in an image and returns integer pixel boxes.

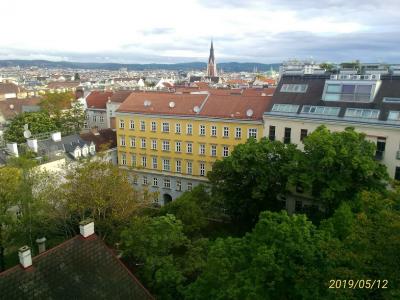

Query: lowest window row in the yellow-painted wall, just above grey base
[121,153,206,176]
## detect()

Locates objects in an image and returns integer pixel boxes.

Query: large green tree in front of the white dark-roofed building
[291,126,388,215]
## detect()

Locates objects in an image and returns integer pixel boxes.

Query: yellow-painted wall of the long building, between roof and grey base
[116,113,263,179]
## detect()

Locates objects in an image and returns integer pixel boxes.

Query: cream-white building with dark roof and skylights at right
[264,74,400,180]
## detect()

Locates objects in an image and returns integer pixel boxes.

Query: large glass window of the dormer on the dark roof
[323,83,373,102]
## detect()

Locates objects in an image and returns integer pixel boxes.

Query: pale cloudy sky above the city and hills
[0,0,400,63]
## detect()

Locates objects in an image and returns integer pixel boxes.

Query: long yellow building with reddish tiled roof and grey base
[116,93,270,204]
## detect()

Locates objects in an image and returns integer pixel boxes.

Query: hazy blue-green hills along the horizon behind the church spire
[0,60,280,72]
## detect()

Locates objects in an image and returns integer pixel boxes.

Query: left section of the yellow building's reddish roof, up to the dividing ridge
[117,92,208,115]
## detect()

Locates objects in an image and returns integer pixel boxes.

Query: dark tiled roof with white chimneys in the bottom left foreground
[0,235,153,300]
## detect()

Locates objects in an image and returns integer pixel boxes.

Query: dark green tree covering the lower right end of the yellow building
[208,138,299,229]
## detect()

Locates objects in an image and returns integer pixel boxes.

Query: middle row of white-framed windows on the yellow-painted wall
[119,135,229,157]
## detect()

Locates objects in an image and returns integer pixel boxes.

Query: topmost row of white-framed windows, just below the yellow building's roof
[119,119,257,139]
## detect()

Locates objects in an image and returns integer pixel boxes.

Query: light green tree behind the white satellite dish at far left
[4,112,58,143]
